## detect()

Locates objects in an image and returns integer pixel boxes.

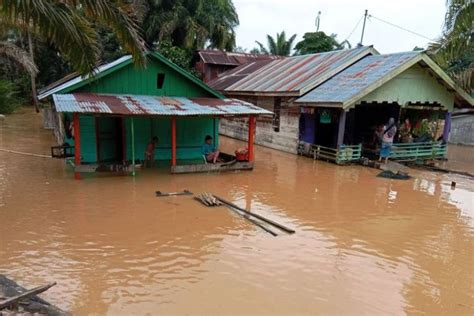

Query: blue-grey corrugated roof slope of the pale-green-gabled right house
[296,52,421,106]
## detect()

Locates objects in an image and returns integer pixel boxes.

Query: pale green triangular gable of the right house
[358,65,454,112]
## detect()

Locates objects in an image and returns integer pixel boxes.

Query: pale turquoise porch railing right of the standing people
[390,142,448,160]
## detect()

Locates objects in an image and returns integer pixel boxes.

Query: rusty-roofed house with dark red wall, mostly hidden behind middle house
[196,49,280,83]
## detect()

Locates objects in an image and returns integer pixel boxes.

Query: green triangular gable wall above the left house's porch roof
[74,58,215,97]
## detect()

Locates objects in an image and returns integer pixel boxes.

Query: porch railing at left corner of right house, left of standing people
[298,143,362,164]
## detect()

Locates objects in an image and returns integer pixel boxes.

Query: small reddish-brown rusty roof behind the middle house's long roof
[198,49,282,66]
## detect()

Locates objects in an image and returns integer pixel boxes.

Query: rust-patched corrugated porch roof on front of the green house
[53,93,272,116]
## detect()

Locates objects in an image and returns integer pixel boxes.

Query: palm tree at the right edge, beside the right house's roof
[428,0,474,93]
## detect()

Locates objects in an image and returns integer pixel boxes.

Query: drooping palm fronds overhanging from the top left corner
[0,0,145,74]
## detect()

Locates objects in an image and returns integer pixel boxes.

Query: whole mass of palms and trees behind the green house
[0,0,238,109]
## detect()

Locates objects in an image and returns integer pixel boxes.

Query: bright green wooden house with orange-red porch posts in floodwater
[38,53,271,178]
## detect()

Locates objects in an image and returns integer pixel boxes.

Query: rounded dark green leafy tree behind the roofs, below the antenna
[295,31,343,55]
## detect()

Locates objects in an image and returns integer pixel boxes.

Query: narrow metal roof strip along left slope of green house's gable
[38,55,132,100]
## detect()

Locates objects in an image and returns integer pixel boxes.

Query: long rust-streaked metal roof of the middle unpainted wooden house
[209,46,378,96]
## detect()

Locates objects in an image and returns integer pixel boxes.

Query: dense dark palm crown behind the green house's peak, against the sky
[143,0,239,50]
